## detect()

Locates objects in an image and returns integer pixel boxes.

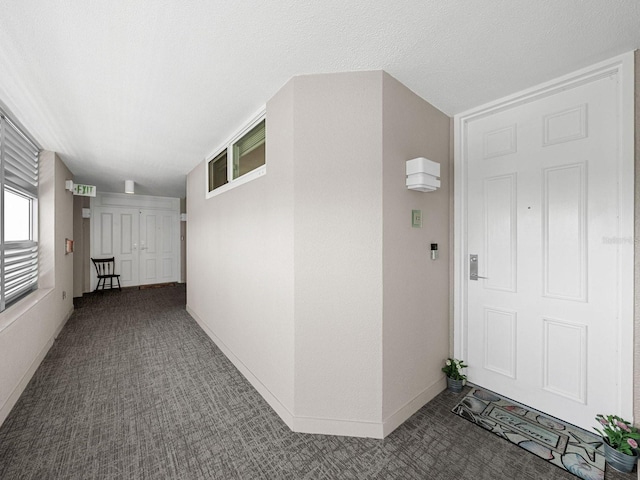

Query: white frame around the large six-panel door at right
[453,52,634,421]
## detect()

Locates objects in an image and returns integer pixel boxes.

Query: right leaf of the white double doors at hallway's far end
[140,210,180,285]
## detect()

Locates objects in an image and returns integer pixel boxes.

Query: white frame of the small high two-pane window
[204,107,267,199]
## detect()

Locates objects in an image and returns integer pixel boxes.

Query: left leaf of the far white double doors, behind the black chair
[92,207,140,288]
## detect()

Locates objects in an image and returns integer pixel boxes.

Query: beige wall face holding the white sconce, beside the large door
[383,75,451,430]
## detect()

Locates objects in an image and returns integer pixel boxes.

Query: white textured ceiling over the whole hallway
[0,0,640,197]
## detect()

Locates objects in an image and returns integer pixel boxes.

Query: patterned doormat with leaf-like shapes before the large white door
[452,387,605,480]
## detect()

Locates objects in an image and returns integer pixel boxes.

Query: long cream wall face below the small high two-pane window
[187,80,294,421]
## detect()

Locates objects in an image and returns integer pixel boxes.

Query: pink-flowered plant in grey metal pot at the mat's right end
[594,414,640,473]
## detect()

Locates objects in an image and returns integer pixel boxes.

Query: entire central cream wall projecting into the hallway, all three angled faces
[187,71,449,437]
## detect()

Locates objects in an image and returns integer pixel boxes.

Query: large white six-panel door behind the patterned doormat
[460,55,633,428]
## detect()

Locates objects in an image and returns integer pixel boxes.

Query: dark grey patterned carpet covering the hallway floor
[0,286,635,480]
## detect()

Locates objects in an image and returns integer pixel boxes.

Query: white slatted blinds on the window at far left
[0,116,38,310]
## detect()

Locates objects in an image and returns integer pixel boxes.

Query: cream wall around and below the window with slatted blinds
[0,152,73,423]
